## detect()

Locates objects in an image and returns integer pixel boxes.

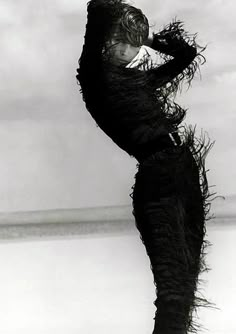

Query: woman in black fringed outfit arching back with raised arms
[76,0,212,334]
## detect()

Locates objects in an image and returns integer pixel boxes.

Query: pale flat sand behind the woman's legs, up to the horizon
[0,202,236,334]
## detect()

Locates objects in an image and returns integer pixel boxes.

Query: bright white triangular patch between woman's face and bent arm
[126,45,163,71]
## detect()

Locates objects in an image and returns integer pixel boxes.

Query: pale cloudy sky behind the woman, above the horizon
[0,0,236,211]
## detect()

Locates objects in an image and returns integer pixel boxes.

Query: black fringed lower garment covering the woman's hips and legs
[131,148,210,334]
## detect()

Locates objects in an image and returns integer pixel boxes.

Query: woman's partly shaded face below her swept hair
[107,36,140,66]
